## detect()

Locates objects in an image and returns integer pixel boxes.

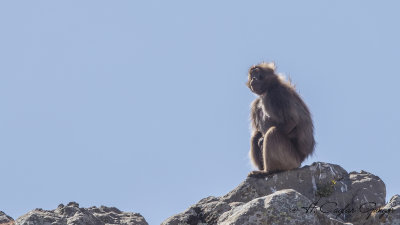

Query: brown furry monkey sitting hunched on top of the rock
[247,63,315,176]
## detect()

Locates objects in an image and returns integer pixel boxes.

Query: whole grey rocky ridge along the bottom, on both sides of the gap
[0,162,400,225]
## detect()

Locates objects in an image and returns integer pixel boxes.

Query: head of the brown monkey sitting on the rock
[246,63,277,95]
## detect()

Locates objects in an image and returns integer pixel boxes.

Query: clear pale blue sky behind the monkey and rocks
[0,0,400,224]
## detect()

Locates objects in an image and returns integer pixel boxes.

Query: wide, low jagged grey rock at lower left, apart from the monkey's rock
[15,202,147,225]
